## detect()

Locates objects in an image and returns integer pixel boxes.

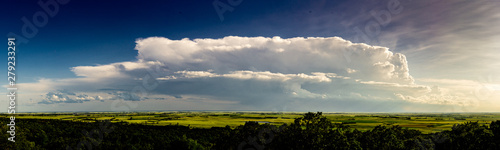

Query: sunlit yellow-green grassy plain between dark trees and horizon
[0,112,500,133]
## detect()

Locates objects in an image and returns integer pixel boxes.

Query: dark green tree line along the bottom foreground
[0,112,500,150]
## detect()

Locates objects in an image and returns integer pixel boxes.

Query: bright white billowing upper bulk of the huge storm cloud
[136,36,413,84]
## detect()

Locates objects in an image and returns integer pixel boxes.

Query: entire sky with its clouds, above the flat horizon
[0,0,500,112]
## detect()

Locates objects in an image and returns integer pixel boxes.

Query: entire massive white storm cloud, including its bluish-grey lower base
[14,36,484,111]
